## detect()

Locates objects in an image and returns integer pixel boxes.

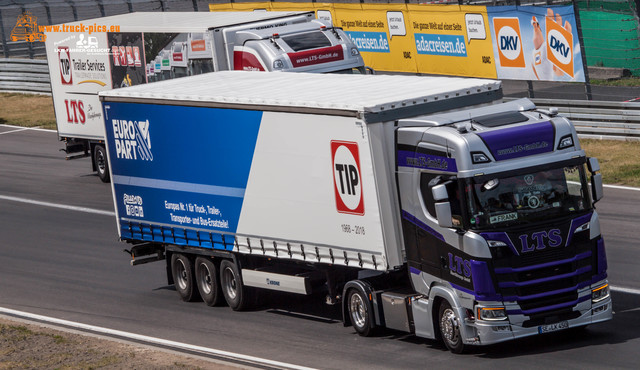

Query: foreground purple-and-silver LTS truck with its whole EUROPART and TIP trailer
[100,71,612,352]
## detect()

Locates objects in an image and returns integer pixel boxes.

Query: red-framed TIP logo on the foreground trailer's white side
[331,140,364,216]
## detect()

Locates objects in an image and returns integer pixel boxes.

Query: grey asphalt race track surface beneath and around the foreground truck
[0,126,640,369]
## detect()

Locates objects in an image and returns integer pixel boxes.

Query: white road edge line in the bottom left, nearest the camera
[0,307,312,370]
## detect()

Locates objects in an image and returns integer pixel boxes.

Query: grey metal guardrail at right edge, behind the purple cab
[531,99,640,141]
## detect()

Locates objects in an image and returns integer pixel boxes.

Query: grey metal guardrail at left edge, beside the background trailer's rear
[0,58,51,94]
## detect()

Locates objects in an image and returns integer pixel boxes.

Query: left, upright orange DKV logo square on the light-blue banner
[493,18,526,68]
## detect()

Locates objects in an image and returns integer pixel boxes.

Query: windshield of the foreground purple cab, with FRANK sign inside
[463,164,591,229]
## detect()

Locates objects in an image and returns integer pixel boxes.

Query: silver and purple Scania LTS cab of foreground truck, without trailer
[397,100,612,345]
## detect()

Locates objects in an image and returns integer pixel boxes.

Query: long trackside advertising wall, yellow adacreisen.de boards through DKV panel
[209,2,584,82]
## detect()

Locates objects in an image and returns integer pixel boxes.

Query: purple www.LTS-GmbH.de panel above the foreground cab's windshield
[478,121,555,161]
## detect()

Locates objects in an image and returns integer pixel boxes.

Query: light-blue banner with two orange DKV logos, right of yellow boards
[487,5,585,82]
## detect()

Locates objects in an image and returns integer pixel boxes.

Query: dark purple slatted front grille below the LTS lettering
[493,228,597,322]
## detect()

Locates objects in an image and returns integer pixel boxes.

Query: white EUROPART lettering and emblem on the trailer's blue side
[111,119,153,161]
